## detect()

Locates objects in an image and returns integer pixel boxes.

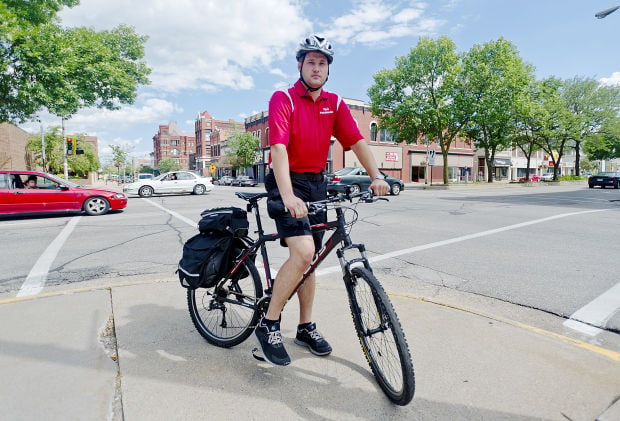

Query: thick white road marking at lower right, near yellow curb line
[564,283,620,336]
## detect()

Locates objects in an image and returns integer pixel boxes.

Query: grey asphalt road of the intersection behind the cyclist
[0,183,620,349]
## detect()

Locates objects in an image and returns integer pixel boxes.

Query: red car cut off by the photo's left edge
[0,171,127,215]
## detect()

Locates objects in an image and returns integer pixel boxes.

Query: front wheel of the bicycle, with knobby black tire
[345,267,415,405]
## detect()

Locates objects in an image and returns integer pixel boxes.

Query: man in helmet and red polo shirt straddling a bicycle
[255,35,389,365]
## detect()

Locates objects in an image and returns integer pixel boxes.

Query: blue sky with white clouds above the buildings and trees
[21,0,620,163]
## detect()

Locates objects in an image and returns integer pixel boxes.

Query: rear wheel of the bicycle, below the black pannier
[187,259,263,348]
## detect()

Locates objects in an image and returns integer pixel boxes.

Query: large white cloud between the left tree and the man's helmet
[60,0,310,92]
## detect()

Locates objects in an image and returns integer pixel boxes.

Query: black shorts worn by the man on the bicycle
[265,172,327,251]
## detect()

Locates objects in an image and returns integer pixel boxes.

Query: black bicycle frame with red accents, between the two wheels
[227,194,372,302]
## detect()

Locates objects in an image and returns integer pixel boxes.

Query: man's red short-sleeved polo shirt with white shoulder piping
[269,80,364,173]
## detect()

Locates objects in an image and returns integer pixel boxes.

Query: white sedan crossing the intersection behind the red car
[123,171,213,197]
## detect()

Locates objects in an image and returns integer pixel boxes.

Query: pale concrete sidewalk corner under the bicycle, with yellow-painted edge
[0,275,620,421]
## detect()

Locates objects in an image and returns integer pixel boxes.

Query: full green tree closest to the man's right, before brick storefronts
[368,36,470,184]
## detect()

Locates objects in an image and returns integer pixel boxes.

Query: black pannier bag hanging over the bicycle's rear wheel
[177,207,249,289]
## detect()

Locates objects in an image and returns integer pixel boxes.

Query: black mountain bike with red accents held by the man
[187,192,415,405]
